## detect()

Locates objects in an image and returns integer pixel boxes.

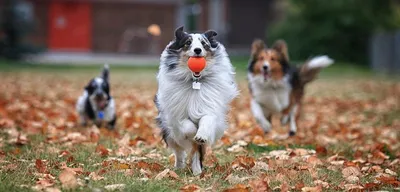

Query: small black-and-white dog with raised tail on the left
[76,64,117,129]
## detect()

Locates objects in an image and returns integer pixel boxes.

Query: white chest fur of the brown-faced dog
[249,75,292,113]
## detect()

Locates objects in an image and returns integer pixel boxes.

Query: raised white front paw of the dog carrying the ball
[194,115,217,145]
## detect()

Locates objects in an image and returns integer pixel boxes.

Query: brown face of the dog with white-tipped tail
[249,40,289,82]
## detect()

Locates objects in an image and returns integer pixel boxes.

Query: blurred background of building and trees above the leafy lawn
[0,0,400,73]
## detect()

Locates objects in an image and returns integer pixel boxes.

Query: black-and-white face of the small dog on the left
[85,77,110,110]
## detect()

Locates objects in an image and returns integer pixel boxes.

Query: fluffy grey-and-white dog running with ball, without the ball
[154,27,238,175]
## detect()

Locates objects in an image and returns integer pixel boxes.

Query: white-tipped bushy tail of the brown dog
[299,55,334,85]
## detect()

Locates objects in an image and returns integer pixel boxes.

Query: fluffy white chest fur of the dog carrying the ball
[158,76,236,123]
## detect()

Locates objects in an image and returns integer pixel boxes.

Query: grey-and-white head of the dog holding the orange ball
[168,27,219,76]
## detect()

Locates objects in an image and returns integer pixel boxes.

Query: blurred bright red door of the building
[48,2,92,51]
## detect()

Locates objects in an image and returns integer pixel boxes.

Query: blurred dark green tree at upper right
[268,0,400,63]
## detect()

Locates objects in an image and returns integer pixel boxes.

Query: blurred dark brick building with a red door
[0,0,275,54]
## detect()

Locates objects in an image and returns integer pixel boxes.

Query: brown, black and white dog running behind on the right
[248,39,333,136]
